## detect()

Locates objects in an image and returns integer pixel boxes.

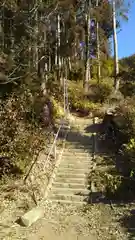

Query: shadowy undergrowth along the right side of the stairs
[93,97,135,201]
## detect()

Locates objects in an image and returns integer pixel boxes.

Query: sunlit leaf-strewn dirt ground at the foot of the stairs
[0,202,134,240]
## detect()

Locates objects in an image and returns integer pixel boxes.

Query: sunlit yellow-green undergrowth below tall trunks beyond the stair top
[68,78,113,115]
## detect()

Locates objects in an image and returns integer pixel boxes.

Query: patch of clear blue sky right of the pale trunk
[112,1,135,59]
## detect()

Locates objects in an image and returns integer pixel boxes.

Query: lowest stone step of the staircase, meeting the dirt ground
[48,192,89,202]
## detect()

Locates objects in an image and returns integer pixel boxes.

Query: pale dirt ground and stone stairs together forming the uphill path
[0,119,127,240]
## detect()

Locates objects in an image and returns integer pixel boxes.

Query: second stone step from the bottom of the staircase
[51,186,90,196]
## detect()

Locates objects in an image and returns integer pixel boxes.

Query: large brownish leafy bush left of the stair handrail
[0,85,45,181]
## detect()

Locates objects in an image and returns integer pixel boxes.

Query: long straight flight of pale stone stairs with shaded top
[48,118,92,204]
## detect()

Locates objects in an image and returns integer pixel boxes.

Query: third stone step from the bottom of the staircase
[52,181,88,189]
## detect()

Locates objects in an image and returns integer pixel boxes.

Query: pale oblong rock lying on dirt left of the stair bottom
[19,207,44,227]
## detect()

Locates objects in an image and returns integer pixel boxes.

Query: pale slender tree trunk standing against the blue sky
[112,0,119,91]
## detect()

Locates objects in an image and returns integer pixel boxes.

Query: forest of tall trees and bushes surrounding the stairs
[0,0,135,238]
